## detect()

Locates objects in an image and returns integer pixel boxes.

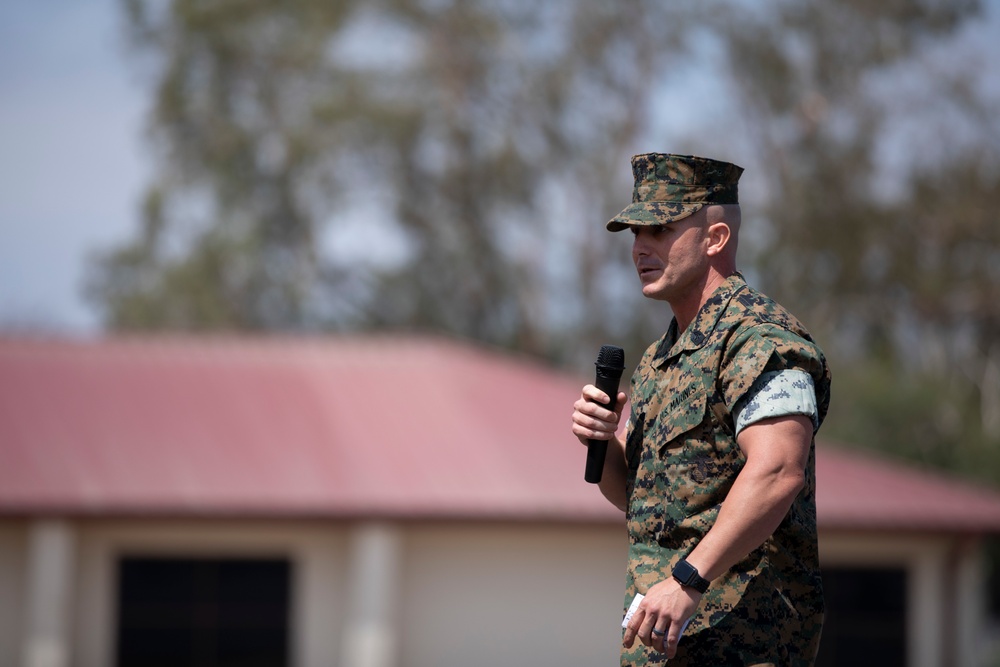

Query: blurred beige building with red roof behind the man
[0,336,1000,667]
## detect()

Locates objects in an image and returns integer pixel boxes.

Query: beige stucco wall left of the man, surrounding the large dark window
[0,520,625,667]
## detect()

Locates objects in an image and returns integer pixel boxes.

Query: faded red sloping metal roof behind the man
[0,336,1000,531]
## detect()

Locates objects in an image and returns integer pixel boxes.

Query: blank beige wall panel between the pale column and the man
[398,523,626,667]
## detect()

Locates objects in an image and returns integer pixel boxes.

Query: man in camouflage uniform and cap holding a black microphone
[572,153,830,666]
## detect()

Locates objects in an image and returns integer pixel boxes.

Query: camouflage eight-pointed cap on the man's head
[607,153,743,232]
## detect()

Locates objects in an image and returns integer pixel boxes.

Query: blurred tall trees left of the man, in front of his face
[89,0,696,356]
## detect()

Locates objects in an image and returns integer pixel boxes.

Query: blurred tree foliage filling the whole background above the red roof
[89,0,1000,481]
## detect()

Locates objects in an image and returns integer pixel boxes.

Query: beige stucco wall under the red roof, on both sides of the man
[0,520,982,667]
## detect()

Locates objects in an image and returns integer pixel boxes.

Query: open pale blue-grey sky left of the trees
[0,0,1000,336]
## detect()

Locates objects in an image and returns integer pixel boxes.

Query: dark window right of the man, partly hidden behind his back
[816,568,906,667]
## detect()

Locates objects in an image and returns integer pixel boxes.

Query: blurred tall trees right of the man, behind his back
[715,0,1000,483]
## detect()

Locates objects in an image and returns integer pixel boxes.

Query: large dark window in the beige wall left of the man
[117,557,291,667]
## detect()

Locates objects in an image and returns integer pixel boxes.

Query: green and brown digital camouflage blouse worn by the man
[622,273,830,665]
